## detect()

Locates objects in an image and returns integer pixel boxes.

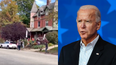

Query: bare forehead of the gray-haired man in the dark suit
[77,9,95,18]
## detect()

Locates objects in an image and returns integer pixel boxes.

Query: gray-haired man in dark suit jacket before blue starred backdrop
[58,5,116,65]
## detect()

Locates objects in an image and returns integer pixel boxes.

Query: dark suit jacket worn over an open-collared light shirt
[58,37,116,65]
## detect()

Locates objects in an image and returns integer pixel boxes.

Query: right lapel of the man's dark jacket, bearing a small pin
[87,37,105,65]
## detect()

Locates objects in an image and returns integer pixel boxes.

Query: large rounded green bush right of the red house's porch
[46,31,58,44]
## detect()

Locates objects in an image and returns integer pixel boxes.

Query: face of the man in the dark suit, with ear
[77,9,101,39]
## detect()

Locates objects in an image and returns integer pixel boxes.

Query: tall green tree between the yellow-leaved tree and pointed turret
[15,0,37,25]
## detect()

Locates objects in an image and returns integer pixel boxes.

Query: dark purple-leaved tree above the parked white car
[1,22,26,41]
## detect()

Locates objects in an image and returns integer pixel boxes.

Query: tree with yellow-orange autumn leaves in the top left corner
[0,0,19,25]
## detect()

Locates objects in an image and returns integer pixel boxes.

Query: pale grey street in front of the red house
[0,49,58,65]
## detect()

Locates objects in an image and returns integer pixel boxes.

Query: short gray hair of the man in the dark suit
[79,5,101,22]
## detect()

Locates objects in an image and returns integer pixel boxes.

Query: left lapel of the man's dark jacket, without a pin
[71,41,80,65]
